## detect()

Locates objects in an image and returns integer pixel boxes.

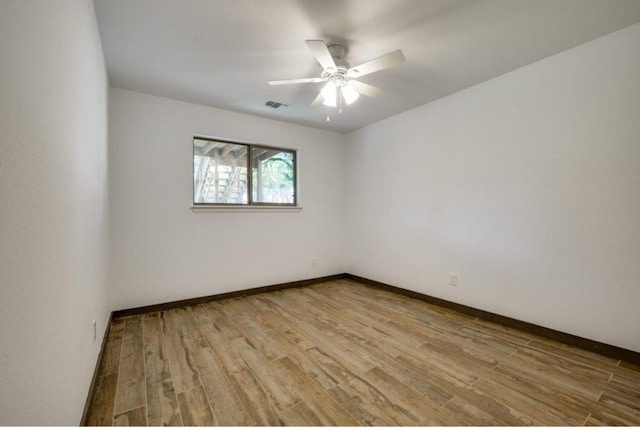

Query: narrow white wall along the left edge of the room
[0,0,110,425]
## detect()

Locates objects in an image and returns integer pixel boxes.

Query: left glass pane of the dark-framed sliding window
[193,138,248,204]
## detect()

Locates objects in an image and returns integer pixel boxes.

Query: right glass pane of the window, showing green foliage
[251,147,296,205]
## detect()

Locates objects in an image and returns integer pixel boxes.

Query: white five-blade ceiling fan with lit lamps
[268,40,405,113]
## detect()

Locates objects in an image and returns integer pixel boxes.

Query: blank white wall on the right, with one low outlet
[346,24,640,351]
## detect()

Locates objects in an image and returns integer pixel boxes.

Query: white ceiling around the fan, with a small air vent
[94,0,640,132]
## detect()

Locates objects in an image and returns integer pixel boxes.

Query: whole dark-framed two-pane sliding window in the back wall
[193,137,296,206]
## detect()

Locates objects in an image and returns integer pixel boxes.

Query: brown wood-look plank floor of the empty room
[88,280,640,425]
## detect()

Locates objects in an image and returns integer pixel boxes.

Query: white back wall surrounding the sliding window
[109,88,345,309]
